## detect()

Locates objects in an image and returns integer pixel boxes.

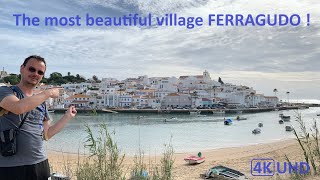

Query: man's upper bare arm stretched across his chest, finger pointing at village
[0,88,62,114]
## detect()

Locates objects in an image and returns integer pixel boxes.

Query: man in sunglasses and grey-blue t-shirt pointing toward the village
[0,56,77,180]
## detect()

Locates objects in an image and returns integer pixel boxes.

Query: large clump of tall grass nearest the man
[76,124,125,180]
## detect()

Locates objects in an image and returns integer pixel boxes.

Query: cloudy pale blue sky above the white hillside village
[0,0,320,99]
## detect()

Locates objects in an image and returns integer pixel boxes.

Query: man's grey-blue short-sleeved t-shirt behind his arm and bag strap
[0,86,49,167]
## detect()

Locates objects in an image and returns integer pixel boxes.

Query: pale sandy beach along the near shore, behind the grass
[48,139,305,180]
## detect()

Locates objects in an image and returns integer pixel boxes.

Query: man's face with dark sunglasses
[20,59,46,86]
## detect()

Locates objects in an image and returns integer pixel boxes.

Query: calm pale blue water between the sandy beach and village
[46,107,320,155]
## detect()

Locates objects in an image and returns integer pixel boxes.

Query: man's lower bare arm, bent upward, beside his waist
[43,106,77,140]
